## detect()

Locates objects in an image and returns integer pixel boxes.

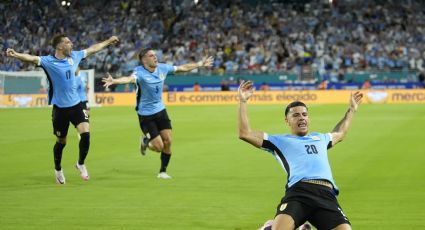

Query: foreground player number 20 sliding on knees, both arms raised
[238,81,363,230]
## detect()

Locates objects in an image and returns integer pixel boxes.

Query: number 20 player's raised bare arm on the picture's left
[238,81,264,148]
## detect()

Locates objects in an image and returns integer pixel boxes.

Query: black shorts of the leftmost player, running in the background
[52,103,89,137]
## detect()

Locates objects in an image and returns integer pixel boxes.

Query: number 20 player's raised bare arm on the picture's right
[331,92,363,146]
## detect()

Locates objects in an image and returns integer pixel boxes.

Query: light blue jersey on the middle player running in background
[132,63,176,116]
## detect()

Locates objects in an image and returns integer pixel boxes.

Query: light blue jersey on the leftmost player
[39,50,86,108]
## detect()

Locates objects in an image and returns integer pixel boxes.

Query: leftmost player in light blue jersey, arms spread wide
[6,34,119,184]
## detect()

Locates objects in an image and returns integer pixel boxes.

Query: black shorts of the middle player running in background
[137,109,172,140]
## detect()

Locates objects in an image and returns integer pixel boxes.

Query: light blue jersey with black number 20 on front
[262,133,338,194]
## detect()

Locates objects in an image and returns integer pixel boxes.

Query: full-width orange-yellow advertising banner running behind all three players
[0,89,425,107]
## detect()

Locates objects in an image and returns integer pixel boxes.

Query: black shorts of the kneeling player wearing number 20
[276,182,351,230]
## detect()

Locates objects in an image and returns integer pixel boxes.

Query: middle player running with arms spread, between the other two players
[102,48,213,179]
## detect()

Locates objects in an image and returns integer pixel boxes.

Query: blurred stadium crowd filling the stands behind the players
[0,0,425,79]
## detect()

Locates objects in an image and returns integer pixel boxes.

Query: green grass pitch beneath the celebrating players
[0,105,425,230]
